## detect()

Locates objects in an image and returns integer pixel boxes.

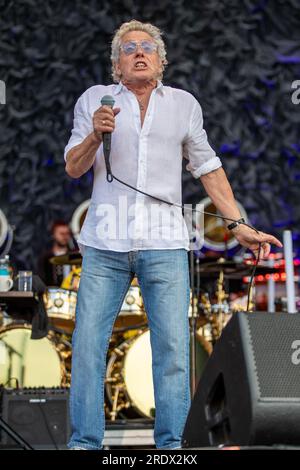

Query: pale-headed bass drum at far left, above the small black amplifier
[0,325,65,387]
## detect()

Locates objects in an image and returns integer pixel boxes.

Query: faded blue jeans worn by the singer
[68,246,190,449]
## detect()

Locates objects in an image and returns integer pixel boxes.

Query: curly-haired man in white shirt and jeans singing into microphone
[65,20,281,449]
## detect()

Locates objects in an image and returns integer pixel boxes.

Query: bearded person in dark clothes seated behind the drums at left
[38,220,74,287]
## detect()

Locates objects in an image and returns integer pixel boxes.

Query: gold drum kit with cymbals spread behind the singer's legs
[0,253,280,421]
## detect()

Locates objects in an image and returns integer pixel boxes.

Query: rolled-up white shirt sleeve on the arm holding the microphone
[64,95,93,160]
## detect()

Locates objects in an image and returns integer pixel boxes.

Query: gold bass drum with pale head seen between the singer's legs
[105,330,210,421]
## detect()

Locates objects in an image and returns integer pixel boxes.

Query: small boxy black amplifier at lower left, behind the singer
[1,388,70,449]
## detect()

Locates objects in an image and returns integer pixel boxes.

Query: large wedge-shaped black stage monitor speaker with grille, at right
[183,312,300,447]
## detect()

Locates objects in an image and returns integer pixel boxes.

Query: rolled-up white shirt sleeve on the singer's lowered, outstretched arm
[183,100,222,178]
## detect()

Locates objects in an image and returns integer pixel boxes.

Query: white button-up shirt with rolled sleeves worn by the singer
[65,81,222,251]
